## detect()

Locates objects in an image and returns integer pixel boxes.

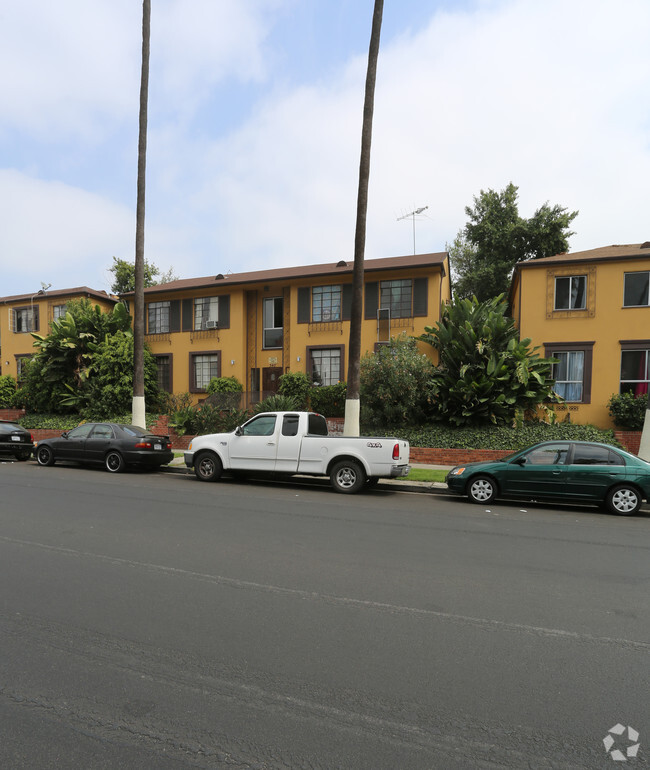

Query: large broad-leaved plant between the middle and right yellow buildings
[418,295,561,426]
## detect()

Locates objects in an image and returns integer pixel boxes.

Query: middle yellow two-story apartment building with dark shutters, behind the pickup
[124,252,451,401]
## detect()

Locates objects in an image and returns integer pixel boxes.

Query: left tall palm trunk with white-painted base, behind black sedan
[132,0,151,427]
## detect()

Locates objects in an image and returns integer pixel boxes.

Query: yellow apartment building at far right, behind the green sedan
[510,242,650,427]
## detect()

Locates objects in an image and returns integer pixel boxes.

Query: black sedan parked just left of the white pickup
[34,422,174,473]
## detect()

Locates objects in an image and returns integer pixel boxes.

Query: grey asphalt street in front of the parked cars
[0,462,650,770]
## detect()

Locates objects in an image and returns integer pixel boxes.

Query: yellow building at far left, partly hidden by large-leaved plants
[0,286,118,382]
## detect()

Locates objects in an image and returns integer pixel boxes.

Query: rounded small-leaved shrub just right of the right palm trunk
[356,335,434,430]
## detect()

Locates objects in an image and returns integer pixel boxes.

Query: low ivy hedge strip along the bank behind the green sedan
[370,422,620,452]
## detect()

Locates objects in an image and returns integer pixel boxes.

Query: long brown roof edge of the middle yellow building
[120,251,448,297]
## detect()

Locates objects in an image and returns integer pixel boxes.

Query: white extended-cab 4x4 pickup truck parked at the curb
[184,412,410,494]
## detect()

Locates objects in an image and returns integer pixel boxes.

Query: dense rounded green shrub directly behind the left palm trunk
[78,330,159,419]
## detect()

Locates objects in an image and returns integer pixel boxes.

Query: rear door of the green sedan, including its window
[565,444,627,500]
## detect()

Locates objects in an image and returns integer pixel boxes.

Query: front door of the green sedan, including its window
[499,441,570,498]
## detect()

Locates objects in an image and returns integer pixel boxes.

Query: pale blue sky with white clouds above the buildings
[0,0,650,296]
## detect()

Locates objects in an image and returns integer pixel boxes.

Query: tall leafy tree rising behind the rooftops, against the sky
[447,182,578,301]
